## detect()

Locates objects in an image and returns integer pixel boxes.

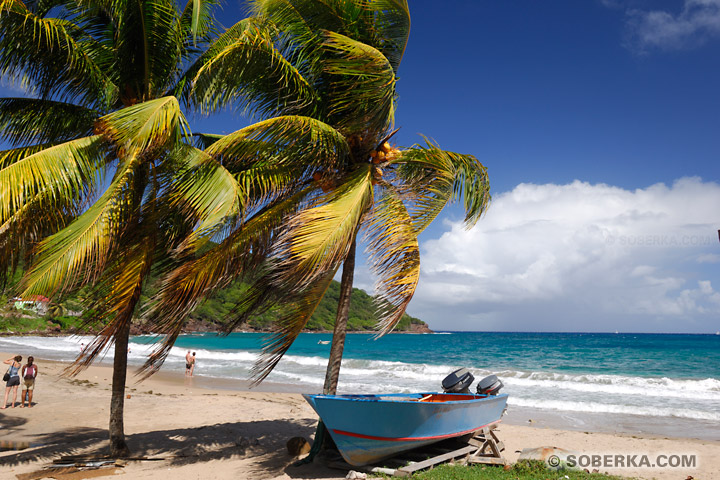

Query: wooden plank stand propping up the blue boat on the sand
[328,425,507,477]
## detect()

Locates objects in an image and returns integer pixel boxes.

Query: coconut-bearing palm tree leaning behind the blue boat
[147,0,490,393]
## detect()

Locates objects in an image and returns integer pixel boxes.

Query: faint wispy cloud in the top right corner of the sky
[627,0,720,52]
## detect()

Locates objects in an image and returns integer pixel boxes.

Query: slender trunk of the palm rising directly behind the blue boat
[323,239,355,395]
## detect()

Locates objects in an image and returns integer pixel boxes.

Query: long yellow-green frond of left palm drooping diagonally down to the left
[20,156,142,296]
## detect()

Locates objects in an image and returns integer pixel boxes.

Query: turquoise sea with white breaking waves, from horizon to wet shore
[0,332,720,440]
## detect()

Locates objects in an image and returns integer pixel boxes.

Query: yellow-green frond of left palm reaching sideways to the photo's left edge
[0,135,105,229]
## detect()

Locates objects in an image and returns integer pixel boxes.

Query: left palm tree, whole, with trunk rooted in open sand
[0,0,218,456]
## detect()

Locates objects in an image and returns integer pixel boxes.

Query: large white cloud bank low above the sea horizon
[411,178,720,331]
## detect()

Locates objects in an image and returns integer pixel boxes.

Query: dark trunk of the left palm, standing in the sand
[109,322,130,458]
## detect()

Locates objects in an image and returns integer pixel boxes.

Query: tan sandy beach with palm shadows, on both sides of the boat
[0,353,720,480]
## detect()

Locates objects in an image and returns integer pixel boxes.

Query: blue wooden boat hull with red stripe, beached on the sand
[303,393,507,466]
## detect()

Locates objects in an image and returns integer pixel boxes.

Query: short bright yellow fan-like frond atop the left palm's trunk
[97,97,189,155]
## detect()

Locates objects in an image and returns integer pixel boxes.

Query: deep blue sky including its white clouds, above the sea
[5,0,720,333]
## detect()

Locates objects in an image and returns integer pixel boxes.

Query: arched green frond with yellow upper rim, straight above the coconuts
[324,32,395,132]
